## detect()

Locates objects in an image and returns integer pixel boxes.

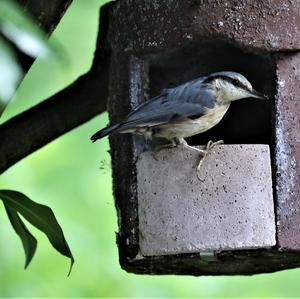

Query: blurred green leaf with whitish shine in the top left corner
[0,0,59,58]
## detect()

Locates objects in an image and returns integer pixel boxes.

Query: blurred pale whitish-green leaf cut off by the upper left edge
[0,37,22,116]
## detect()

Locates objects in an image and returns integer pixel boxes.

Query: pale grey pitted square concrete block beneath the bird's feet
[137,145,276,256]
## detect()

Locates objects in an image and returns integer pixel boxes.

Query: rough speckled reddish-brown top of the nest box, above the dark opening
[111,0,300,51]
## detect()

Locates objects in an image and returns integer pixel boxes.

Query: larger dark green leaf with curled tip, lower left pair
[0,190,74,274]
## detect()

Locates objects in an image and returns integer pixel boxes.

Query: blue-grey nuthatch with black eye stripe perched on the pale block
[91,72,265,148]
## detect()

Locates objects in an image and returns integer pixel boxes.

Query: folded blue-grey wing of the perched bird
[119,81,214,130]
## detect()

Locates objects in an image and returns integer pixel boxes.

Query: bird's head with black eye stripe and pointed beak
[204,72,267,103]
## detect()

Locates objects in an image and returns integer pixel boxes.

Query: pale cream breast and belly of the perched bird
[155,104,230,139]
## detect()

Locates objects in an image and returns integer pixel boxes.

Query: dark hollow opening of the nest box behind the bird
[149,41,275,145]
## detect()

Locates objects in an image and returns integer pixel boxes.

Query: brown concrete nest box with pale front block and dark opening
[101,0,300,275]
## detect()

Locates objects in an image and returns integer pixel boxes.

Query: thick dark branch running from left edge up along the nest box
[0,4,111,173]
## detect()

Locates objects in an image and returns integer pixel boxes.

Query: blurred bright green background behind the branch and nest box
[0,0,300,297]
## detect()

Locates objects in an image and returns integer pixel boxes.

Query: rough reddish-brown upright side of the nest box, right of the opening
[275,52,300,250]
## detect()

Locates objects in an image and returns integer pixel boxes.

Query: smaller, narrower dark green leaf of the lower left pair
[4,205,37,269]
